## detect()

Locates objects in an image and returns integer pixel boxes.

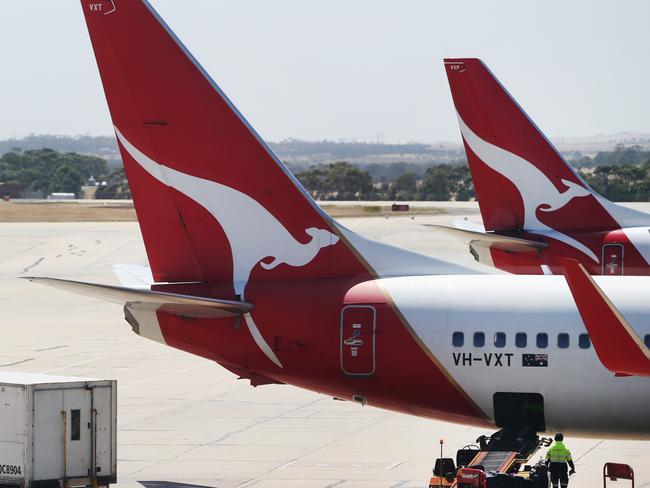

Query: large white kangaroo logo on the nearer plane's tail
[115,127,339,367]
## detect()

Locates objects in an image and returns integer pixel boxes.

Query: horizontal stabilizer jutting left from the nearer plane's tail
[24,277,253,318]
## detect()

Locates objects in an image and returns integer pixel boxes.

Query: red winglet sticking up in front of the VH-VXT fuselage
[560,259,650,376]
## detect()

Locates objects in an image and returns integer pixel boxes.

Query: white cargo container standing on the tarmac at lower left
[0,372,117,488]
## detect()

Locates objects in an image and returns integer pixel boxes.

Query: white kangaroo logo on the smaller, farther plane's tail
[458,115,599,262]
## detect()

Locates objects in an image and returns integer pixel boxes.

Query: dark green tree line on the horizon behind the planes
[0,146,650,201]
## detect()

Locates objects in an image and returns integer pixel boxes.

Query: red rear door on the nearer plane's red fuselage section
[341,305,375,376]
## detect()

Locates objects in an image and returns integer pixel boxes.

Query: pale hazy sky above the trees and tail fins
[0,0,650,142]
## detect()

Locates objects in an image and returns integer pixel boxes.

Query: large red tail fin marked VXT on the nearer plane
[81,0,366,294]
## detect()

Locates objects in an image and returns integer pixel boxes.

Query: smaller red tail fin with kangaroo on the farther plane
[445,58,649,231]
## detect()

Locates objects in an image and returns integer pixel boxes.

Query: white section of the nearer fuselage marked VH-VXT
[379,275,650,438]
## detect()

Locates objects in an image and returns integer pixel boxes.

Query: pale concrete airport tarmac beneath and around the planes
[0,204,650,488]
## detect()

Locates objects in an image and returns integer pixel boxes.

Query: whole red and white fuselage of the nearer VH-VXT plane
[130,275,650,438]
